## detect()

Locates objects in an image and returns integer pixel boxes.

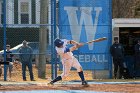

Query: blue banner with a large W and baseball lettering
[59,0,112,70]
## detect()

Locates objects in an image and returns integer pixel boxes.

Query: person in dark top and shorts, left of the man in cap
[3,45,14,80]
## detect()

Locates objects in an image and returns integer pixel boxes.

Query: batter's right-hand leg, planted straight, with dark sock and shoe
[72,58,88,86]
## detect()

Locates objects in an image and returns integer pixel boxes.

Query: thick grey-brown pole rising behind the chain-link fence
[38,0,49,79]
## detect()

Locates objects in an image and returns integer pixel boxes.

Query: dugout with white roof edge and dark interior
[112,18,140,77]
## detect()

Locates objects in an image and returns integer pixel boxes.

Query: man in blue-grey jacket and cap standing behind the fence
[19,40,35,81]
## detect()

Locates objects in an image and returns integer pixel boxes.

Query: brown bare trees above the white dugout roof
[112,0,140,18]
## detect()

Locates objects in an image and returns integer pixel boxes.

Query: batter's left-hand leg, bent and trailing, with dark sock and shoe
[48,60,72,85]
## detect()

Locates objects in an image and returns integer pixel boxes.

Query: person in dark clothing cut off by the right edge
[134,39,140,78]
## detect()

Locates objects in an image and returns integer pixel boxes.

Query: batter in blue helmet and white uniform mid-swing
[48,39,88,86]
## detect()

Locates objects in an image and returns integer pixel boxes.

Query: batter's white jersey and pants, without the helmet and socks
[56,39,82,79]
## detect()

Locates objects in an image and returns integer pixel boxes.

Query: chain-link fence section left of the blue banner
[0,0,51,81]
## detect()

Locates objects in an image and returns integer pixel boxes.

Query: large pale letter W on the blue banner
[64,7,102,50]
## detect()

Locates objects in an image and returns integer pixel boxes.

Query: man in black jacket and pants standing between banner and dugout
[110,37,124,79]
